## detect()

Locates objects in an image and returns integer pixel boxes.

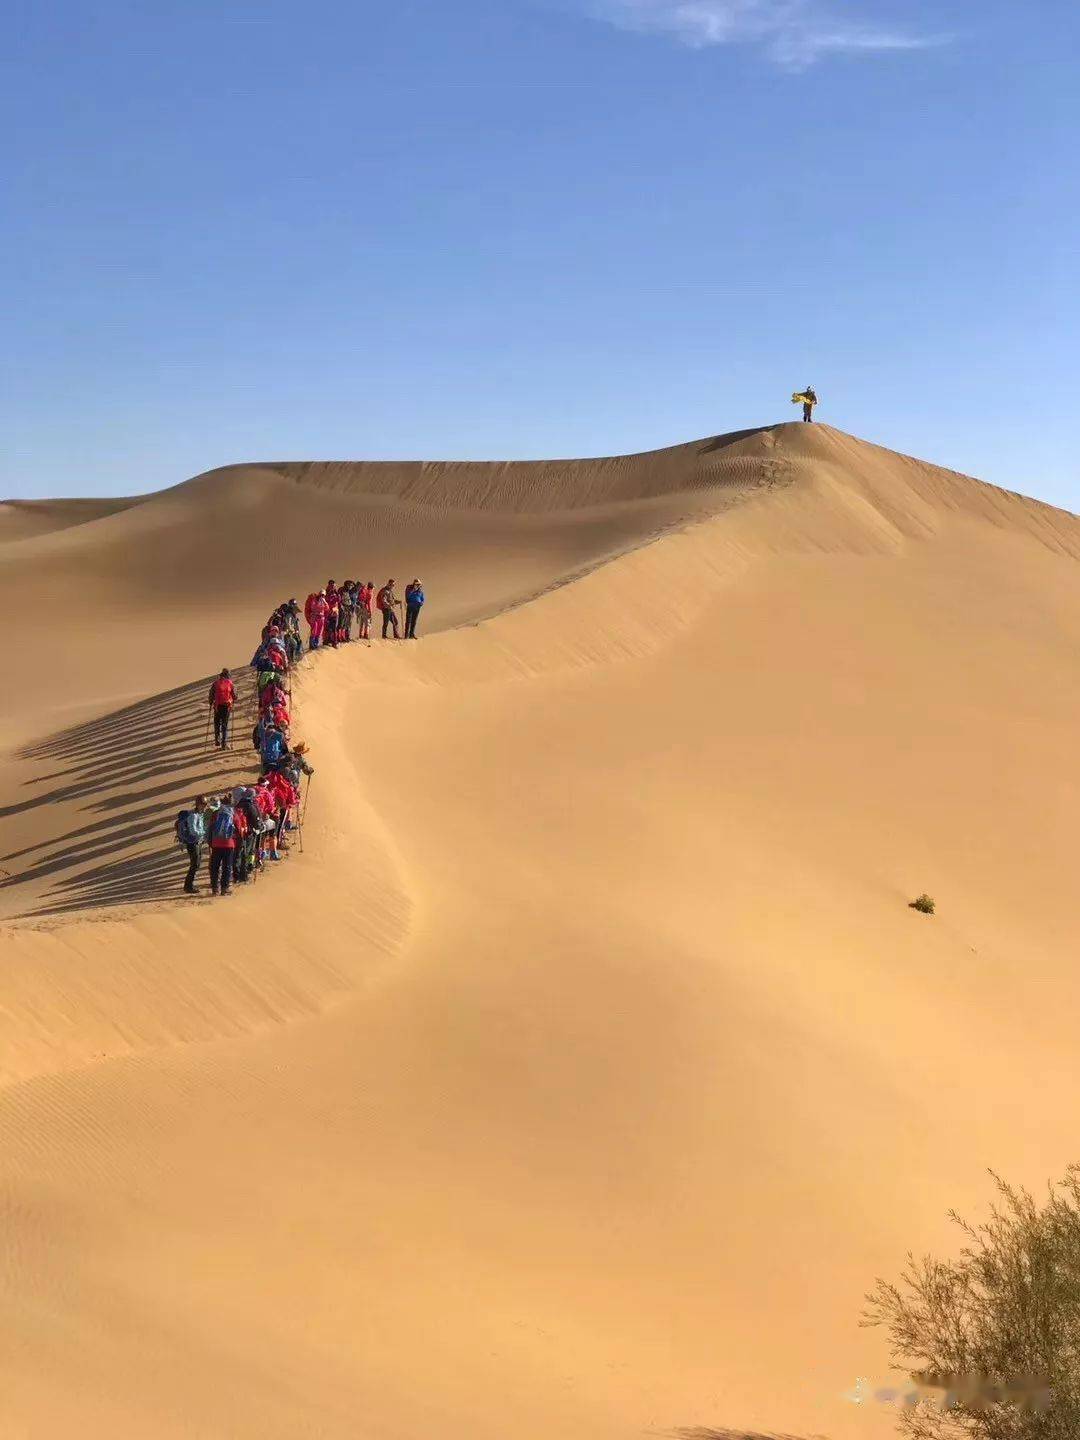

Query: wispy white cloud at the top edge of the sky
[589,0,940,71]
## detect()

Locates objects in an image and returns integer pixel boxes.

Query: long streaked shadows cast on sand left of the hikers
[0,671,258,919]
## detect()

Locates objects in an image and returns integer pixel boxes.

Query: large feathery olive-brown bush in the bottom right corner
[863,1165,1080,1440]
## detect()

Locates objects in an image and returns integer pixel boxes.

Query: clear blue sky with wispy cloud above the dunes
[0,0,1080,510]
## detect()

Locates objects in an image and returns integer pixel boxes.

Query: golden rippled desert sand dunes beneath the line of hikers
[0,425,1080,1440]
